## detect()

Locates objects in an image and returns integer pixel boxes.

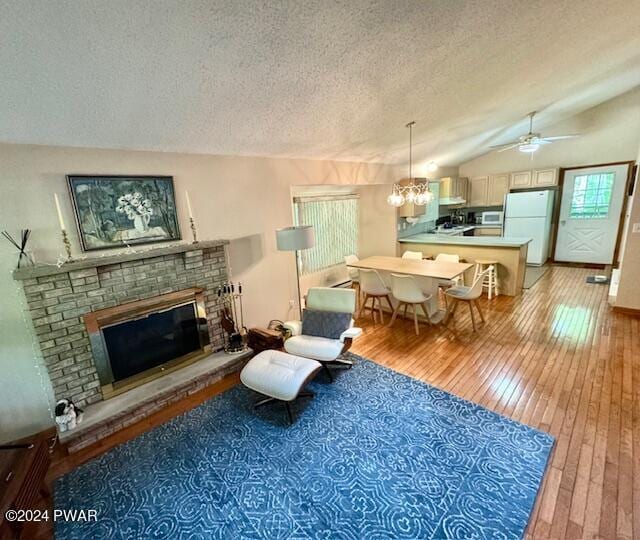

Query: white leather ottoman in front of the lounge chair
[240,350,322,422]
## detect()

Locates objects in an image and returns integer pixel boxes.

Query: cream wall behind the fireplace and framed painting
[0,144,396,440]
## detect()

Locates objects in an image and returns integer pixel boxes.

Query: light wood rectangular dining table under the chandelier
[347,255,473,324]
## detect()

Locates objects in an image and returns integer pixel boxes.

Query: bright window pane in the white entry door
[569,173,616,219]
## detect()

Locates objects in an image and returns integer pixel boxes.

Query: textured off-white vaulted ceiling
[0,0,640,165]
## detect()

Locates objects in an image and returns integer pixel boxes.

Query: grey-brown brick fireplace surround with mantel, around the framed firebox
[14,240,228,407]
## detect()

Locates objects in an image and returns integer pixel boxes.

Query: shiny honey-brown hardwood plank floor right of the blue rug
[352,266,640,539]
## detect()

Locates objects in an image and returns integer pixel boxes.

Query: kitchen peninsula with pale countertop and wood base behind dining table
[398,233,532,296]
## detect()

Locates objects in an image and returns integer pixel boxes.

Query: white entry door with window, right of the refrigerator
[555,165,629,264]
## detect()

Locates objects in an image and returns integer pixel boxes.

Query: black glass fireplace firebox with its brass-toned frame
[84,288,211,398]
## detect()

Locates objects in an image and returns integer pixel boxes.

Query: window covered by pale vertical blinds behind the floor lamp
[294,195,358,275]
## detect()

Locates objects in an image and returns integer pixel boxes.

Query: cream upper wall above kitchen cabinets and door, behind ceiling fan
[460,88,640,177]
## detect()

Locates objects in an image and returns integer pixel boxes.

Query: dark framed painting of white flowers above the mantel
[67,174,180,251]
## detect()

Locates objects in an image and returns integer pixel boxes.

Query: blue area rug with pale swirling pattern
[55,356,553,540]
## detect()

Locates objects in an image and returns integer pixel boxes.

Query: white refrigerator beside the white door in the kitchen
[503,190,553,266]
